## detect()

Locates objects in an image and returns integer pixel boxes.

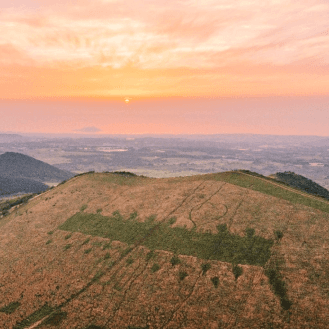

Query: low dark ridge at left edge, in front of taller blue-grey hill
[0,176,48,197]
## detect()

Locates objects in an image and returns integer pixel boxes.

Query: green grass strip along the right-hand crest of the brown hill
[210,171,329,213]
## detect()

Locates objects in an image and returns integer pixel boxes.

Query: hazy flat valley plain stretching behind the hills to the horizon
[0,134,329,189]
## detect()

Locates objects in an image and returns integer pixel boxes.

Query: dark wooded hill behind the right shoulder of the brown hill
[269,171,329,200]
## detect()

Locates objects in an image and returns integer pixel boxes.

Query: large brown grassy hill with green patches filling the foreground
[0,171,329,329]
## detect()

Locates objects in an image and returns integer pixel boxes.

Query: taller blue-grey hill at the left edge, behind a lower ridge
[0,152,74,182]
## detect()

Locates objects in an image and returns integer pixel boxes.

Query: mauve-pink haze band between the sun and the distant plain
[0,97,329,136]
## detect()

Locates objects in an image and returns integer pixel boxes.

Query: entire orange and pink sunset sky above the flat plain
[0,0,329,135]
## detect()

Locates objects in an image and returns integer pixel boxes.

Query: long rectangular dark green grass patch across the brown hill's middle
[59,212,273,266]
